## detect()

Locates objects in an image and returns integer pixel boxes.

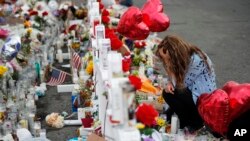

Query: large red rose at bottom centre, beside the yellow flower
[136,103,158,126]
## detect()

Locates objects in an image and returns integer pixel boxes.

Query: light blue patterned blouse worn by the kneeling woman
[184,54,216,103]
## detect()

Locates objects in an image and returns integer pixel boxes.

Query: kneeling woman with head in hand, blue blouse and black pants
[156,36,216,130]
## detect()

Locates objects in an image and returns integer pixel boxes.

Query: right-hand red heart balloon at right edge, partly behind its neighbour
[222,81,250,122]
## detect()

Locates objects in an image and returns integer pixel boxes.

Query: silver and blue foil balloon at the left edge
[1,35,21,61]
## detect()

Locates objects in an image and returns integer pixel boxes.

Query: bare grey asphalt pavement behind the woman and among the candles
[38,0,250,141]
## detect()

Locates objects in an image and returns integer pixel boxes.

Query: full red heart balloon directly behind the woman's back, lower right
[198,89,229,135]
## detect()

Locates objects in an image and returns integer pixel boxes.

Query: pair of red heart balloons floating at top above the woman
[117,0,170,40]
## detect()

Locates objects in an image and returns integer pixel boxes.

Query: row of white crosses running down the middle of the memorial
[89,0,140,141]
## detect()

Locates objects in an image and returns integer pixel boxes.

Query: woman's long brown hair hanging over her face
[156,35,211,87]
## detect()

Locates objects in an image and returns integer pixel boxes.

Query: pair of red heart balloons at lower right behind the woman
[198,81,250,135]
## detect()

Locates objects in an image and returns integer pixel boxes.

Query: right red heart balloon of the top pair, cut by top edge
[142,0,170,32]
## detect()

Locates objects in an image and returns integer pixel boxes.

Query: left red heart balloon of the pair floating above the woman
[117,6,149,40]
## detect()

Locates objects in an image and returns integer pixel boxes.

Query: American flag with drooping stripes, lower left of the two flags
[47,69,67,86]
